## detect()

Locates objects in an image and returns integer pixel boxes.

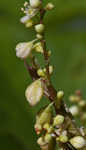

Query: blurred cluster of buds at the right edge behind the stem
[69,91,86,123]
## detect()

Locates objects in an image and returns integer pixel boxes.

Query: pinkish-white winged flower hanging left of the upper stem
[16,41,33,59]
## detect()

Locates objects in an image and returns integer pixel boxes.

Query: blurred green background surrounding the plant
[0,0,86,150]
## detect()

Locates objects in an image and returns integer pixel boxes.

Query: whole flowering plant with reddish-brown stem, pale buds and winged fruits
[16,0,86,150]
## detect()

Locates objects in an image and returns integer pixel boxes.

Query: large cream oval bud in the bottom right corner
[70,136,86,149]
